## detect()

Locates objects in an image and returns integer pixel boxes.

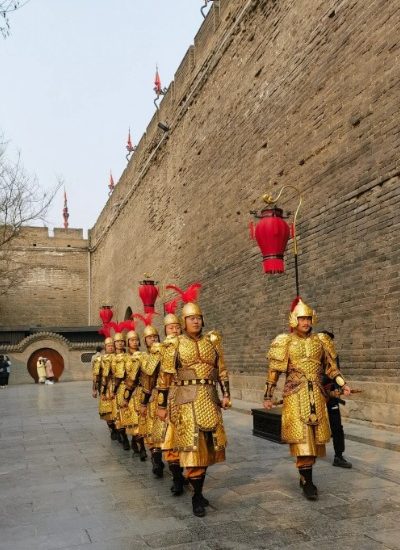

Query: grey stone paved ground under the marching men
[0,382,400,550]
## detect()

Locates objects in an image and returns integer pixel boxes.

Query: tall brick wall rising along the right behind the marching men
[90,0,400,424]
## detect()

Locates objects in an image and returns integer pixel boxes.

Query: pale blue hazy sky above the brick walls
[0,0,211,234]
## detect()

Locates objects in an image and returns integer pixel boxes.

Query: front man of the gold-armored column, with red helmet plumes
[158,283,230,517]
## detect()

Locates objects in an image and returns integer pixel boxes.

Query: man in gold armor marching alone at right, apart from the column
[264,298,350,500]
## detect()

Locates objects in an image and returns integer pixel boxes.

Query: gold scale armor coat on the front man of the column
[160,332,228,467]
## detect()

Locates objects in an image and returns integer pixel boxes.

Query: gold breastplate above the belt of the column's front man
[178,336,217,380]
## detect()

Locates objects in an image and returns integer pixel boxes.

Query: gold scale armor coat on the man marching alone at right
[267,333,341,456]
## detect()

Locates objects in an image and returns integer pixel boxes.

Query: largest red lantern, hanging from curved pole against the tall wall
[253,207,290,273]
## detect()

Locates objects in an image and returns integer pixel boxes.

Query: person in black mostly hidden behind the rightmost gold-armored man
[322,330,352,468]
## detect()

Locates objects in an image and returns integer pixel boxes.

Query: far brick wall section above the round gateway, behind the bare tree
[0,227,89,327]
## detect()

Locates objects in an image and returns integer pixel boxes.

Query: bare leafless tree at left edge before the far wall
[0,140,63,295]
